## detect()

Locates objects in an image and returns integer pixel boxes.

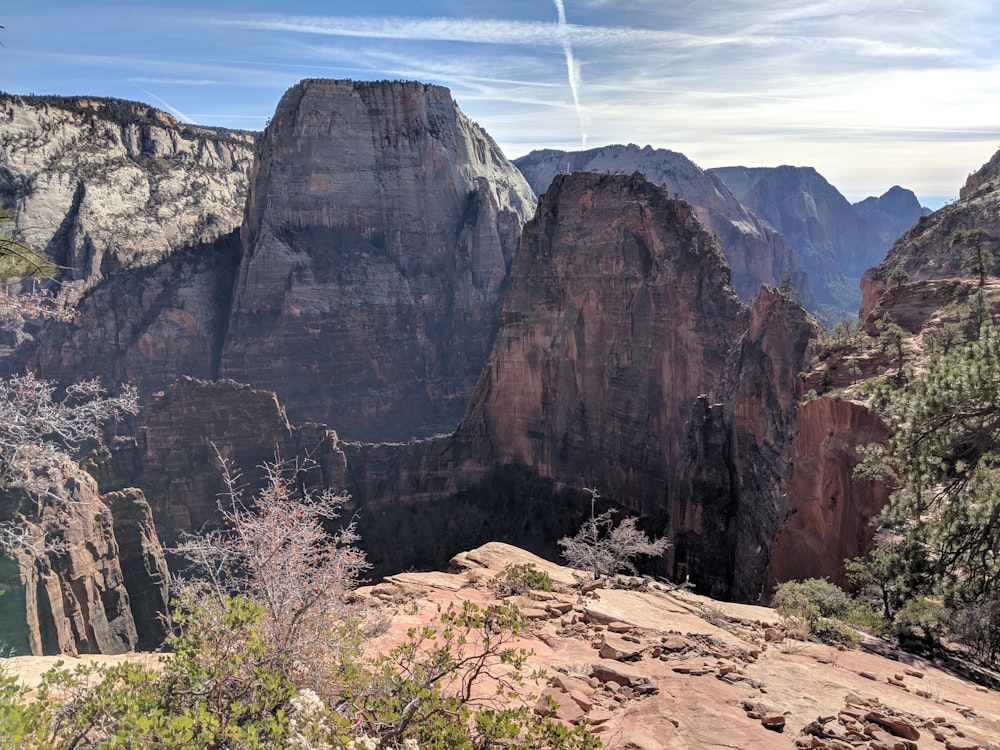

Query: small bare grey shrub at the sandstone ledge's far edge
[559,488,670,578]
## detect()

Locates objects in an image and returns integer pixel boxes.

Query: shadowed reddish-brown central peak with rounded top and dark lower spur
[458,173,816,598]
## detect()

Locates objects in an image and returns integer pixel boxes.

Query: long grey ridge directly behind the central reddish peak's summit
[514,145,814,305]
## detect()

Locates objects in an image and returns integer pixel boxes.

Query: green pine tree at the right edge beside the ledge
[861,321,1000,657]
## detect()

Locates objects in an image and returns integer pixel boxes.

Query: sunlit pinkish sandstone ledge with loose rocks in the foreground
[7,543,1000,750]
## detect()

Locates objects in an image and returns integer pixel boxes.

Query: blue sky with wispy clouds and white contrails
[0,0,1000,207]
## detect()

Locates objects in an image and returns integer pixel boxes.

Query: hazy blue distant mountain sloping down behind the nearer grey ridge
[709,166,898,318]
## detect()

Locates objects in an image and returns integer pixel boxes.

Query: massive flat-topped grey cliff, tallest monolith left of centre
[220,81,534,440]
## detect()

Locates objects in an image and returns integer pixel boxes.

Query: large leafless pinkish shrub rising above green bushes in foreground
[173,456,370,695]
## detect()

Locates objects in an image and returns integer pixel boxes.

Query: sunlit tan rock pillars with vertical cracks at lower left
[0,460,168,654]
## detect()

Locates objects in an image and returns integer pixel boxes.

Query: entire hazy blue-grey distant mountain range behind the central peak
[514,144,930,324]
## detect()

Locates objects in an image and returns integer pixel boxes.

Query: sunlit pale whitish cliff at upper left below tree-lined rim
[0,94,254,294]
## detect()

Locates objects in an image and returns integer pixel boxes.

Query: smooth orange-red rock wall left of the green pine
[765,398,889,593]
